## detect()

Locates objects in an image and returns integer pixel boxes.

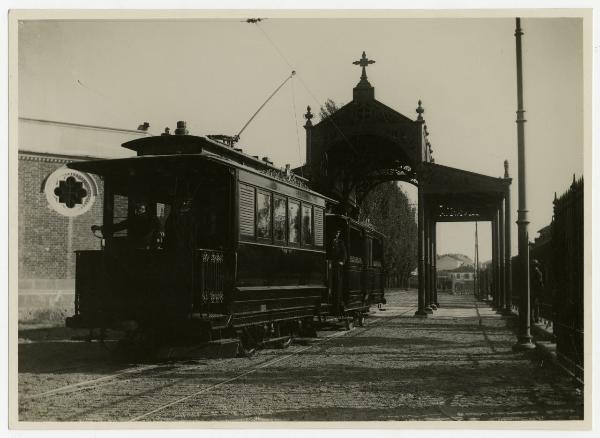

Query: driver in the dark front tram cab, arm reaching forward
[92,201,163,249]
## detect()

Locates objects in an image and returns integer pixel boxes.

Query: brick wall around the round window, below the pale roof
[18,153,102,322]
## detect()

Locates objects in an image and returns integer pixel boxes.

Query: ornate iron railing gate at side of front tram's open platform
[194,249,226,313]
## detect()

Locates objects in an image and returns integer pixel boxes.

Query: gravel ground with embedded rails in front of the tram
[18,290,583,421]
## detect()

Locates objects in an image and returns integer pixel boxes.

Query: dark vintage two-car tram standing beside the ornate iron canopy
[66,124,384,348]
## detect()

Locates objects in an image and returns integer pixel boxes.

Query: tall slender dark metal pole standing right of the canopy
[513,17,535,350]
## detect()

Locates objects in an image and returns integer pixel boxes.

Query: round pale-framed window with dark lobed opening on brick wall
[43,166,98,217]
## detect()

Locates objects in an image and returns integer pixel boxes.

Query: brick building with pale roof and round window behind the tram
[17,118,149,322]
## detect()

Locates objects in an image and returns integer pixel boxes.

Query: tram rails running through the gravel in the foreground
[19,307,416,422]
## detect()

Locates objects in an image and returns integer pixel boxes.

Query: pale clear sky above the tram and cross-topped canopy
[18,15,583,261]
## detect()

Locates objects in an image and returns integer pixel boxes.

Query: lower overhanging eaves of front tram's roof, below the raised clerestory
[67,151,337,204]
